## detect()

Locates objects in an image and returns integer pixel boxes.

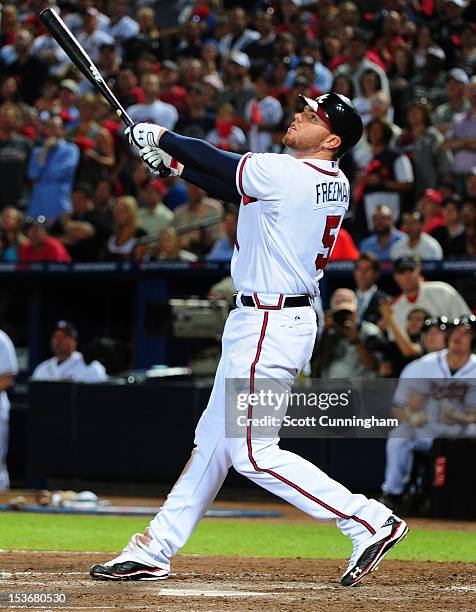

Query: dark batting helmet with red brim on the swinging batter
[301,91,364,157]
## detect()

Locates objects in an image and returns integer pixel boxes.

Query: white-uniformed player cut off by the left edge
[0,329,18,491]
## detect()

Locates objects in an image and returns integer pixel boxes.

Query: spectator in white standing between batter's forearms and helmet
[245,74,283,153]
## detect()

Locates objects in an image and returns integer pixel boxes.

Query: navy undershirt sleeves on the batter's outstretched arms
[160,132,241,185]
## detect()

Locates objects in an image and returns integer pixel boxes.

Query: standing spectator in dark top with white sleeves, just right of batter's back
[355,119,414,233]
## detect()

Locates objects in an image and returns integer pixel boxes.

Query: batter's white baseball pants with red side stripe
[138,294,392,569]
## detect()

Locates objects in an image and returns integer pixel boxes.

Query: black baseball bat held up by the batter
[40,8,170,178]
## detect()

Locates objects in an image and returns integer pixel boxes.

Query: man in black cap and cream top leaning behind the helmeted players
[393,256,471,327]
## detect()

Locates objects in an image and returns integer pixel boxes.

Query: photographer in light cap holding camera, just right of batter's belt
[318,289,385,378]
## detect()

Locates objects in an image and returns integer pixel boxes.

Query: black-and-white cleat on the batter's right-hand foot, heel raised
[340,515,408,586]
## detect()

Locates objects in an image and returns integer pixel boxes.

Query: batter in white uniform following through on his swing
[90,92,407,586]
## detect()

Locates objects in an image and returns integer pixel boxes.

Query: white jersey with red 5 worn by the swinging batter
[231,153,350,296]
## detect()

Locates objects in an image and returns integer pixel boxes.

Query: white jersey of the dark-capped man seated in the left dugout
[31,351,107,382]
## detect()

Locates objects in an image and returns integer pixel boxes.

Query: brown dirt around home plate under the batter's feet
[0,551,476,612]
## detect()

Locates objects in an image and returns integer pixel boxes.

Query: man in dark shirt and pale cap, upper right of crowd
[402,46,446,108]
